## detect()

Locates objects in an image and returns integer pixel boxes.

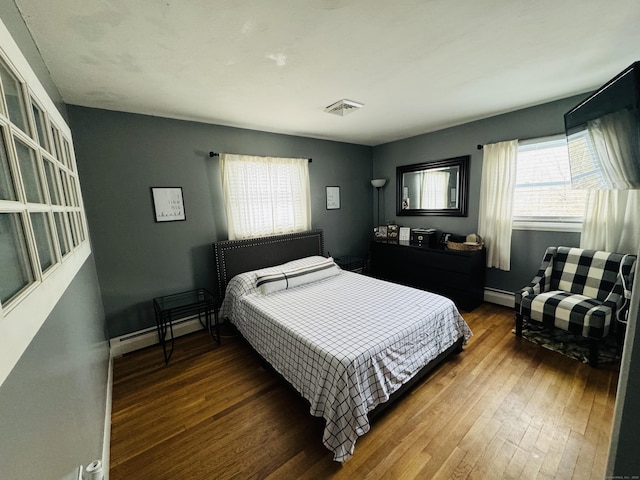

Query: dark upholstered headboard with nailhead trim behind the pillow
[213,230,324,301]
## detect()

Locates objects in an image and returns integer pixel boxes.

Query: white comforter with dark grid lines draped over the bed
[221,260,471,462]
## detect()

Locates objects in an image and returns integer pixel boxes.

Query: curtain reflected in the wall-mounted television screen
[587,110,640,190]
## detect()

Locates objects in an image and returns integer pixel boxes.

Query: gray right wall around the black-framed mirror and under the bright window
[373,95,586,291]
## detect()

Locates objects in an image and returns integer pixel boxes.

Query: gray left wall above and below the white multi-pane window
[0,1,109,480]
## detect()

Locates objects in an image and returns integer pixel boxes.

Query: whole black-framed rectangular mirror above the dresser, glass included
[396,155,470,217]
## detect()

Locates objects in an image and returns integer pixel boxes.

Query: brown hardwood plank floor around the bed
[111,304,618,480]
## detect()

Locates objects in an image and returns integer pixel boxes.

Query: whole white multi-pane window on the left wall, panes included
[0,25,91,385]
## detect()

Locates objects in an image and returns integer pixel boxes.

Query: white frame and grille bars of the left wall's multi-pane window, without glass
[0,19,91,385]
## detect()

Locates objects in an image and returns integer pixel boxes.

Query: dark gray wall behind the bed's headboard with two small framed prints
[67,105,372,337]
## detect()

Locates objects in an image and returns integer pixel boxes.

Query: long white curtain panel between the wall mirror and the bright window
[478,140,518,270]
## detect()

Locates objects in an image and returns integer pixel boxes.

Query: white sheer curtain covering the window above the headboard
[220,154,311,240]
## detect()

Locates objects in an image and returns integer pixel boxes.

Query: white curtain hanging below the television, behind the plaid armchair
[580,190,640,255]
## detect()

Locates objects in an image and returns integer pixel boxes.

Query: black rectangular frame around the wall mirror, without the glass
[396,155,471,217]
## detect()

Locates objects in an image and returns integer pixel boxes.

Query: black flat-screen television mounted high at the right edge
[564,61,640,190]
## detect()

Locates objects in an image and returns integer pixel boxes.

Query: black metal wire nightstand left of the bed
[153,288,220,365]
